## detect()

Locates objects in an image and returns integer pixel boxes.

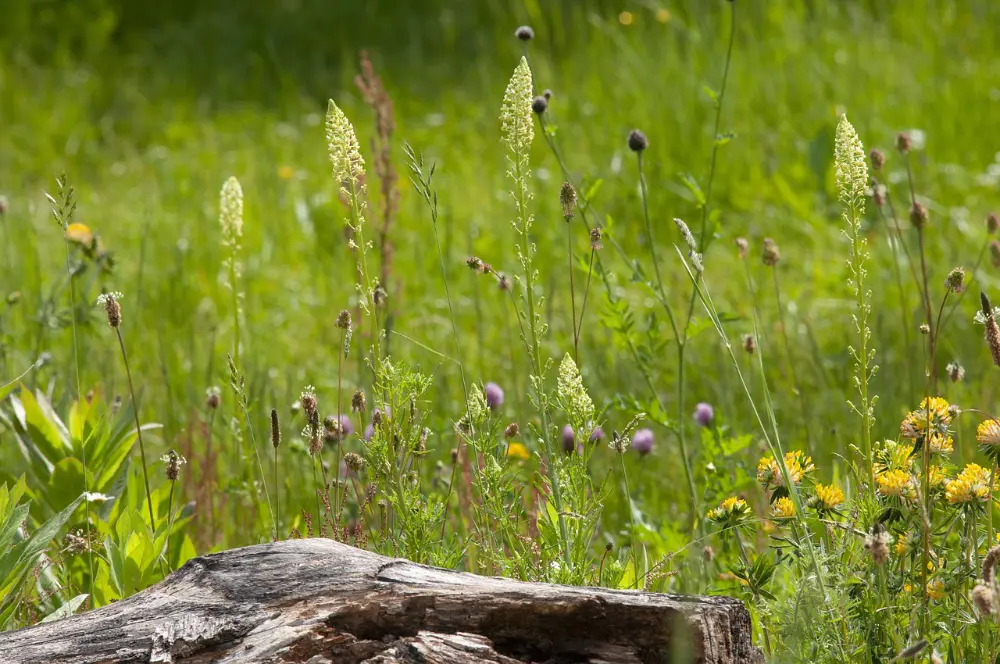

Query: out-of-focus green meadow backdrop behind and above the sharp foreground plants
[0,0,1000,548]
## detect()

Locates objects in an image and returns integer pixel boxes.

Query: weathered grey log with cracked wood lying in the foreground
[0,539,763,664]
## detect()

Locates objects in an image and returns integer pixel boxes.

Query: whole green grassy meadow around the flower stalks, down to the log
[0,0,1000,662]
